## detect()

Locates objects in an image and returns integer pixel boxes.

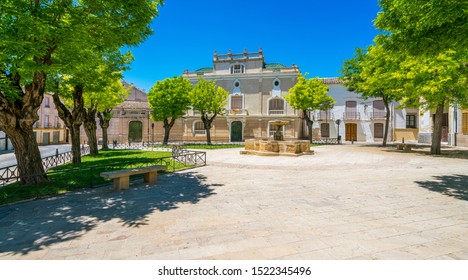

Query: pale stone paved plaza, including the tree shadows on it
[0,145,468,260]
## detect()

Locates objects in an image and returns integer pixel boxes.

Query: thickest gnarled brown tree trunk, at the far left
[0,71,47,184]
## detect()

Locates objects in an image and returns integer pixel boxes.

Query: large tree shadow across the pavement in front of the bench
[0,172,221,256]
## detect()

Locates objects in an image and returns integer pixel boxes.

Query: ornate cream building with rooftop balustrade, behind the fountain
[177,49,303,142]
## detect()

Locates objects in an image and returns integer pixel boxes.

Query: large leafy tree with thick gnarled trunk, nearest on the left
[0,0,162,183]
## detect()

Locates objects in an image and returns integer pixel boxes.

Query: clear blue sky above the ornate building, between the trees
[124,0,379,91]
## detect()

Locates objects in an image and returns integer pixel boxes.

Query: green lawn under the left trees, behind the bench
[0,150,186,205]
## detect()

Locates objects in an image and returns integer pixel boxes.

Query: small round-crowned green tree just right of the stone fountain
[284,74,335,143]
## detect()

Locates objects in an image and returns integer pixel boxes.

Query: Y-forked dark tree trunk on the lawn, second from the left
[53,84,84,165]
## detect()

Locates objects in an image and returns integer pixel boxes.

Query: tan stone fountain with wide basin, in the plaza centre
[241,120,314,157]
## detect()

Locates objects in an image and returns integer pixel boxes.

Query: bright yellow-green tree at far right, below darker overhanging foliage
[393,51,468,154]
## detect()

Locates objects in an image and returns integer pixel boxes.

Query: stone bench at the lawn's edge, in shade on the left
[100,165,167,190]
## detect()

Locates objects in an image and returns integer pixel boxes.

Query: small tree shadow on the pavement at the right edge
[416,175,468,200]
